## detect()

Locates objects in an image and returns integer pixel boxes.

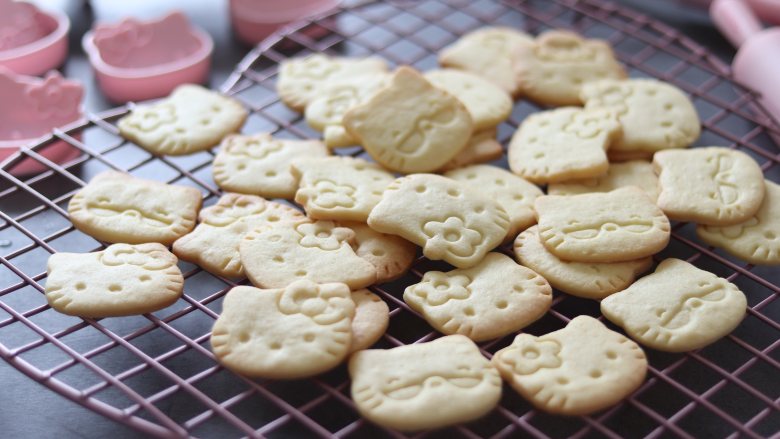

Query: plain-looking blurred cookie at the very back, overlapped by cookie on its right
[439,27,534,96]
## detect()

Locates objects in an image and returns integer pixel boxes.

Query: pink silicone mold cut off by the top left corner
[0,0,70,75]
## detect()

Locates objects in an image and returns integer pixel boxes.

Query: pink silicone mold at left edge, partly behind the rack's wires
[0,67,84,175]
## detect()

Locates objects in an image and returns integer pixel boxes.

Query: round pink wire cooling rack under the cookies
[0,0,780,438]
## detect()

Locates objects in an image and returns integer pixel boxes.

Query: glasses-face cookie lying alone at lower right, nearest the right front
[601,259,747,352]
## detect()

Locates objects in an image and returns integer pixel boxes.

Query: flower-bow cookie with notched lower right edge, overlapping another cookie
[507,107,620,184]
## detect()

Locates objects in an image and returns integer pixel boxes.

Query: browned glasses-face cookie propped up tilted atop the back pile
[344,67,474,173]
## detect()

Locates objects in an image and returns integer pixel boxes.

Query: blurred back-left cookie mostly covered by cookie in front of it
[276,53,387,112]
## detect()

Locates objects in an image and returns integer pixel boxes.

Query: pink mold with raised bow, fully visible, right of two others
[82,12,214,102]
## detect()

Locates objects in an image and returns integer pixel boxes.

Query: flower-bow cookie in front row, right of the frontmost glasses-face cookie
[492,316,647,415]
